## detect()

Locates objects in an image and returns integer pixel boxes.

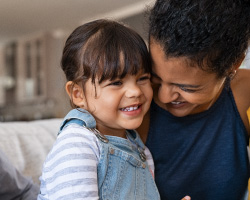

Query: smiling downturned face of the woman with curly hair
[150,41,225,117]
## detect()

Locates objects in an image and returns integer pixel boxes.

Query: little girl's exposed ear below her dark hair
[65,81,86,108]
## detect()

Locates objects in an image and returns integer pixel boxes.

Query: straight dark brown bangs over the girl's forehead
[82,26,151,83]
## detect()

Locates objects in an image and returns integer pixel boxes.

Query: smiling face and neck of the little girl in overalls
[84,70,153,137]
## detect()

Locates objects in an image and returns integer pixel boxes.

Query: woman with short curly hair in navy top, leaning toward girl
[139,0,250,200]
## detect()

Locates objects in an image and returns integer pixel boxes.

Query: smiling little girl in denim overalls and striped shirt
[38,20,160,200]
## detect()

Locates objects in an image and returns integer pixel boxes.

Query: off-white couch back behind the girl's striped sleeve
[0,119,62,184]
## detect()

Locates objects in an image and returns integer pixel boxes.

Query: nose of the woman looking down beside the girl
[158,85,180,103]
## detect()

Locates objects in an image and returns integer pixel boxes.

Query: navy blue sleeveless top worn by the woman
[146,88,249,200]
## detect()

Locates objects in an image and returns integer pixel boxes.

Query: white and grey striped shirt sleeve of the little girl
[38,124,101,200]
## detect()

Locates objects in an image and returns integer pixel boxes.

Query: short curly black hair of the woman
[149,0,250,77]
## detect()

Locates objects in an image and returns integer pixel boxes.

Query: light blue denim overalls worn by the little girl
[59,109,160,200]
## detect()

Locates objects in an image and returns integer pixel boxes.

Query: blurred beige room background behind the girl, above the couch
[0,0,154,122]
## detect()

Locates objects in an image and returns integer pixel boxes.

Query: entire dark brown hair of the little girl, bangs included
[61,19,151,84]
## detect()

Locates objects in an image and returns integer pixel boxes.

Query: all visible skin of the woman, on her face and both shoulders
[138,40,250,142]
